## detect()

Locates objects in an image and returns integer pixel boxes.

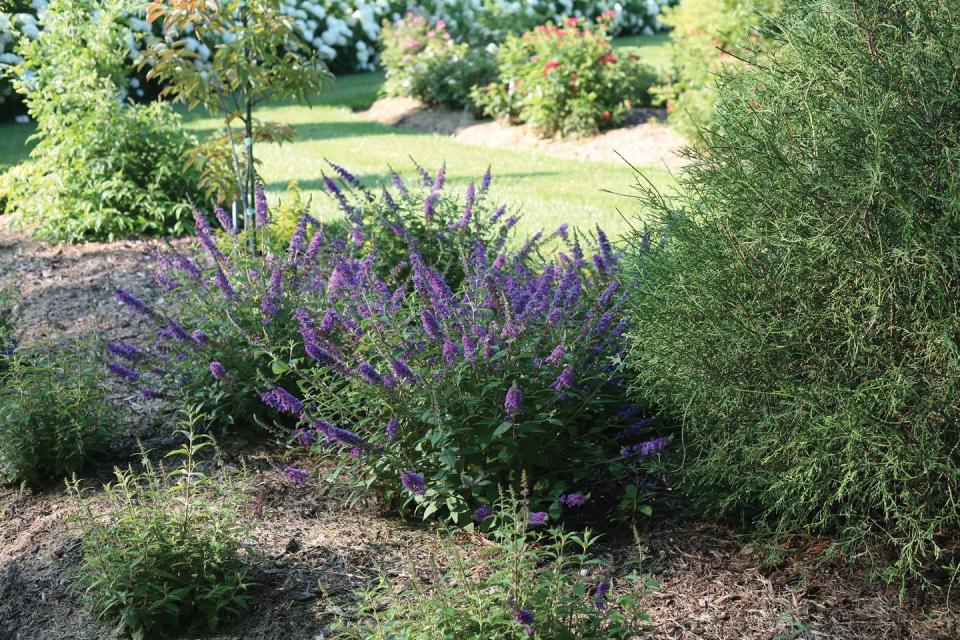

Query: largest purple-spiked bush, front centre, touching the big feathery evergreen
[284,215,644,523]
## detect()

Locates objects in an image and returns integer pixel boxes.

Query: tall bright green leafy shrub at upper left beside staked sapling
[5,0,197,241]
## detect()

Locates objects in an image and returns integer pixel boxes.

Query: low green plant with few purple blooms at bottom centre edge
[334,494,652,640]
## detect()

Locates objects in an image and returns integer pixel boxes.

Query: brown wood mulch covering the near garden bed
[0,219,960,640]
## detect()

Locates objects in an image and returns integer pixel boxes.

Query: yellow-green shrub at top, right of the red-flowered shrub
[655,0,782,141]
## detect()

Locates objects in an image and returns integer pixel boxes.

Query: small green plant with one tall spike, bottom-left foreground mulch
[71,414,250,639]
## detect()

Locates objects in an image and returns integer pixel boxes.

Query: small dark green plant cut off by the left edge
[0,342,117,486]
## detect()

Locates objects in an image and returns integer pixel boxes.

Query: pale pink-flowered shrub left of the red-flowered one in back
[382,13,496,107]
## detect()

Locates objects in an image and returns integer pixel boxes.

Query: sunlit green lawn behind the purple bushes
[0,36,671,234]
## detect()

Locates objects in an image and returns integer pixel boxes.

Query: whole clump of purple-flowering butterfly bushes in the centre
[111,159,662,526]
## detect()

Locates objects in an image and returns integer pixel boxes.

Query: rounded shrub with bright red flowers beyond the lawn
[470,18,655,137]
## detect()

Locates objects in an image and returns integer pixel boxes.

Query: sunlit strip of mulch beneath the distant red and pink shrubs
[362,98,686,170]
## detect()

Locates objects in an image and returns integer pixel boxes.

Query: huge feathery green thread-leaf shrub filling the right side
[631,0,960,578]
